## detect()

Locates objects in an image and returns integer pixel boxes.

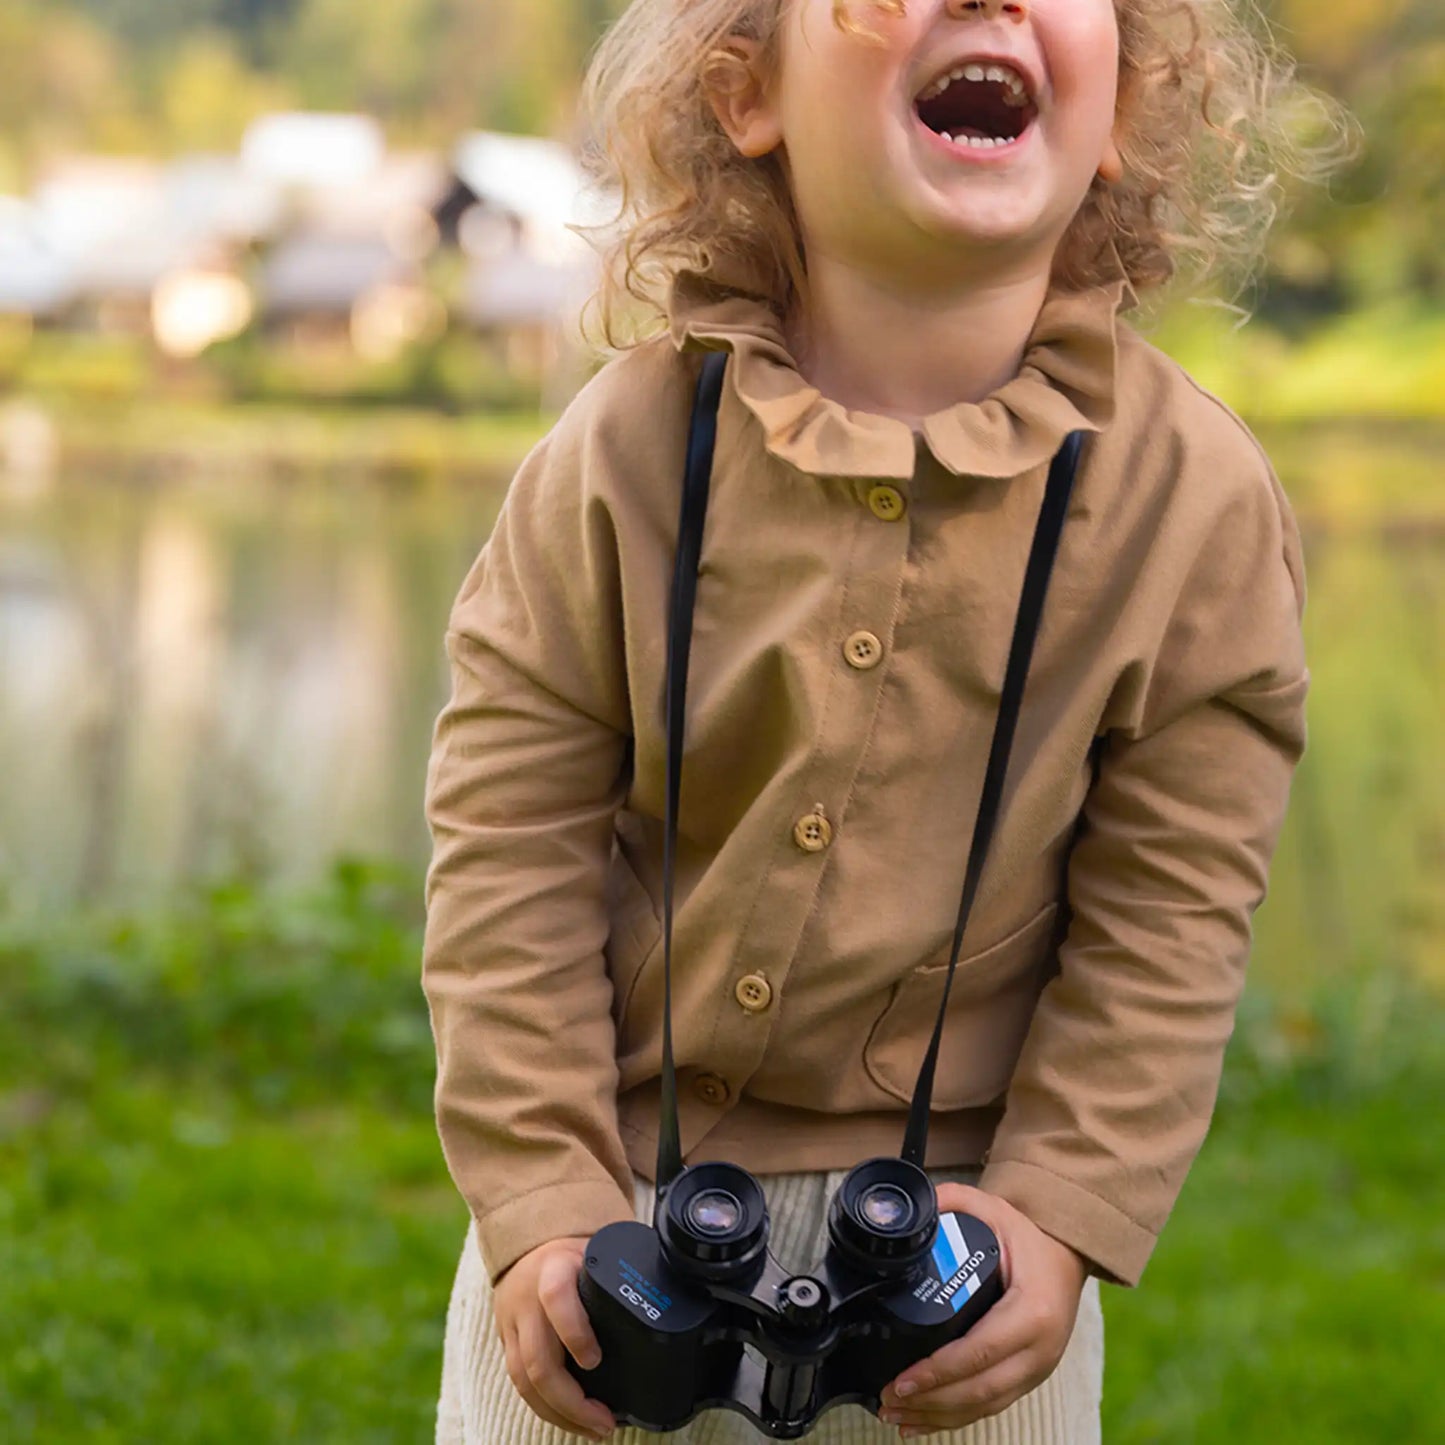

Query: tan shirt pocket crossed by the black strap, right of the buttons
[863,903,1059,1108]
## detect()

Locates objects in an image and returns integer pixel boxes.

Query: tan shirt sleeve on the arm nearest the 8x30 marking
[422,403,633,1280]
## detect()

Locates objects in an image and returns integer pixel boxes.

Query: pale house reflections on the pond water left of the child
[0,478,503,912]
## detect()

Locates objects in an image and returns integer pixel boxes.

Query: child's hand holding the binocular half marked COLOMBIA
[881,1183,1088,1438]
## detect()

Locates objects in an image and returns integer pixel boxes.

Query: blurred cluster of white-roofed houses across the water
[0,113,621,384]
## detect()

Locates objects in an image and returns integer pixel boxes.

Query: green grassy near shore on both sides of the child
[0,864,1445,1445]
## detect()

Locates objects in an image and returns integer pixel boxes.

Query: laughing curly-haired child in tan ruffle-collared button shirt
[425,0,1329,1445]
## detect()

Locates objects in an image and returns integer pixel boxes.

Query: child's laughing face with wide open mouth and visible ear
[728,0,1118,288]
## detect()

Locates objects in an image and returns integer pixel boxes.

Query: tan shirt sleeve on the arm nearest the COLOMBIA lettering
[981,453,1309,1286]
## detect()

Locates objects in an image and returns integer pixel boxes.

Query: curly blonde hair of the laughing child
[582,0,1348,348]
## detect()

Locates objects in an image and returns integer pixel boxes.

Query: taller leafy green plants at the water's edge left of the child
[0,863,431,1111]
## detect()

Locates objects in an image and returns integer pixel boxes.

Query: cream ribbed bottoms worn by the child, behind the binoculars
[436,1169,1104,1445]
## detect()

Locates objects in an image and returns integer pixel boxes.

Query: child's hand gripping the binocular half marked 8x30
[491,1238,617,1439]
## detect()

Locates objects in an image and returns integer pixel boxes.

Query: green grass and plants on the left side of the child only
[0,867,465,1445]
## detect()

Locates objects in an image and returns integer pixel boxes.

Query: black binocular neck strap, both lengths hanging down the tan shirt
[657,351,1084,1196]
